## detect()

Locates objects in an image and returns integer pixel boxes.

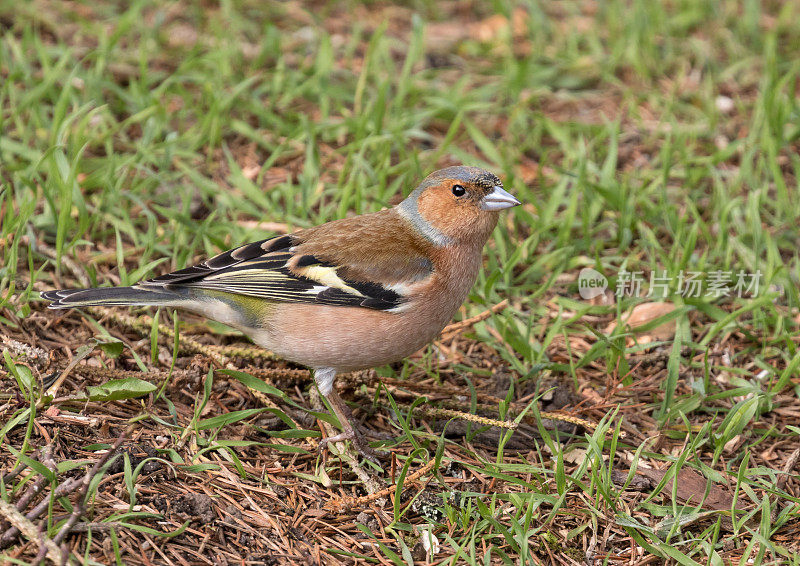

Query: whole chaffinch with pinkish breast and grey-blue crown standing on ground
[41,167,519,460]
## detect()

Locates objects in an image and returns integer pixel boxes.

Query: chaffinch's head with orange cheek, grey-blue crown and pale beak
[397,166,520,245]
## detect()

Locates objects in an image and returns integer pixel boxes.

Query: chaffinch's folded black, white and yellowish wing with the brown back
[138,211,433,310]
